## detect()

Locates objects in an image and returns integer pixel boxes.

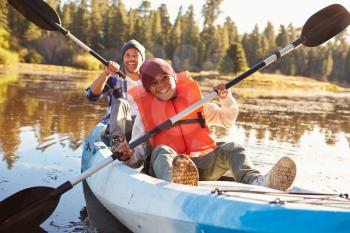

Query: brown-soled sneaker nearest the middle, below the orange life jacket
[172,155,199,186]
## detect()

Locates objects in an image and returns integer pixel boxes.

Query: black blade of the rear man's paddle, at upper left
[8,0,61,31]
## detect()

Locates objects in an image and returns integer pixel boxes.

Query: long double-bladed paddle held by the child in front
[0,0,350,230]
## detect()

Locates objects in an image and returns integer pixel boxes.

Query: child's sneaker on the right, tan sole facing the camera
[251,157,297,191]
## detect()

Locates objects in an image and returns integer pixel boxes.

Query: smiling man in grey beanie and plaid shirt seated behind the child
[86,40,145,144]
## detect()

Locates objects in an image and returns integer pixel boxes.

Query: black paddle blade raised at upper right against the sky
[301,4,350,47]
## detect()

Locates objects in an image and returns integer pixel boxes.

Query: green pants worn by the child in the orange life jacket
[151,142,260,184]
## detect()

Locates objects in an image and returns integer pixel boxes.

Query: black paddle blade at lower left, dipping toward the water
[0,187,60,232]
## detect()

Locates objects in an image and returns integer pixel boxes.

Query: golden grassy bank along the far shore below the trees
[0,63,350,97]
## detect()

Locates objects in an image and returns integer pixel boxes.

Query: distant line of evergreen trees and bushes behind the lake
[0,0,350,84]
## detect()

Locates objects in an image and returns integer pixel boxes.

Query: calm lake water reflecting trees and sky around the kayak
[0,74,350,232]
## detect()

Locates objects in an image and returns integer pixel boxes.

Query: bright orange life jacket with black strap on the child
[129,72,216,155]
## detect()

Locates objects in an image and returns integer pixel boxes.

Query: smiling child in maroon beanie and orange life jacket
[117,58,296,191]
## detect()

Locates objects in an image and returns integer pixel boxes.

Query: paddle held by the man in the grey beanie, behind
[8,0,136,84]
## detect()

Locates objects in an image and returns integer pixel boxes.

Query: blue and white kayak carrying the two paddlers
[82,123,350,233]
